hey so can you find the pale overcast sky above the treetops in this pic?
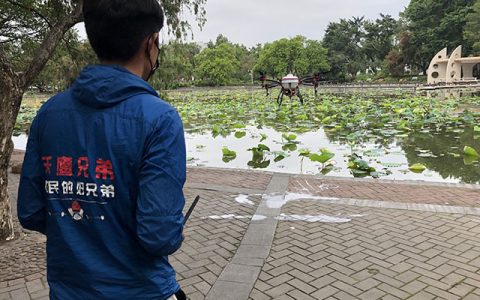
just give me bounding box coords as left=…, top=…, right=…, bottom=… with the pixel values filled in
left=77, top=0, right=410, bottom=47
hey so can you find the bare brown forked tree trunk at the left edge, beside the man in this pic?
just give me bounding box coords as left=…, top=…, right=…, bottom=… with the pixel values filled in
left=0, top=0, right=83, bottom=241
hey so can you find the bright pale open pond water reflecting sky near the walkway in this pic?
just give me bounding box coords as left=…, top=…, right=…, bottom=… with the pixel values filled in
left=186, top=126, right=458, bottom=182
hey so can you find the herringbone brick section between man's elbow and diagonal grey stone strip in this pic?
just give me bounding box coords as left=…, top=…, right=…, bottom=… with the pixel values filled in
left=170, top=189, right=260, bottom=299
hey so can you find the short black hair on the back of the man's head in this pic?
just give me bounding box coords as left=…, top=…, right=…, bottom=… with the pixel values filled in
left=83, top=0, right=164, bottom=62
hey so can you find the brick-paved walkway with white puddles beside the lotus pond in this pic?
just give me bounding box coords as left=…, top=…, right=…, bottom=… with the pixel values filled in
left=0, top=151, right=480, bottom=300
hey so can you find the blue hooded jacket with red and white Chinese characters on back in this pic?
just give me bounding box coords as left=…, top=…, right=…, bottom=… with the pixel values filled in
left=18, top=65, right=186, bottom=300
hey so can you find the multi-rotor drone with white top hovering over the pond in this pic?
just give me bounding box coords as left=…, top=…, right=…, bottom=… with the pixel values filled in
left=259, top=73, right=323, bottom=106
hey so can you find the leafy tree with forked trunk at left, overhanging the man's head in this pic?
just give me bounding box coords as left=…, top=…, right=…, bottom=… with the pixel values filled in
left=0, top=0, right=206, bottom=240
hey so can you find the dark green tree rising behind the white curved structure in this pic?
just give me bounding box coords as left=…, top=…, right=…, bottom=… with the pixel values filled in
left=403, top=0, right=478, bottom=74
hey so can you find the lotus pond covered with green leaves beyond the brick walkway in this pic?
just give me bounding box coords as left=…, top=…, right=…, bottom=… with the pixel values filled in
left=14, top=90, right=480, bottom=183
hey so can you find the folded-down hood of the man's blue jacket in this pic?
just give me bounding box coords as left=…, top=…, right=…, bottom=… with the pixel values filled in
left=72, top=65, right=158, bottom=108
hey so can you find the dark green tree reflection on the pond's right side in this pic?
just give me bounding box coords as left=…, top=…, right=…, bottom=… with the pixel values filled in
left=326, top=125, right=480, bottom=183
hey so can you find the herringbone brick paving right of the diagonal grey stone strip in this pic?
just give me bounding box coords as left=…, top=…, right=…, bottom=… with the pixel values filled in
left=250, top=201, right=480, bottom=300
